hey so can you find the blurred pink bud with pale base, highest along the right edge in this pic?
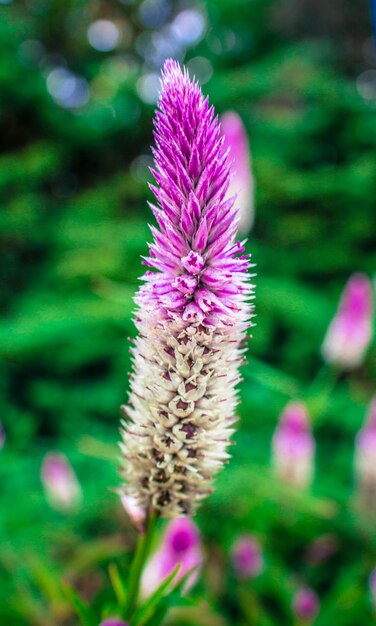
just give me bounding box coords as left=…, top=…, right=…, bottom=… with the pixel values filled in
left=321, top=274, right=373, bottom=370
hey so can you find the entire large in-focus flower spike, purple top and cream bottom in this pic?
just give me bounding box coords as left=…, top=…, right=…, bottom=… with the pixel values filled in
left=121, top=60, right=252, bottom=517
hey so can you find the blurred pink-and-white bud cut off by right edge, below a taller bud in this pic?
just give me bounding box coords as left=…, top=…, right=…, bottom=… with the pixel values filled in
left=355, top=396, right=376, bottom=513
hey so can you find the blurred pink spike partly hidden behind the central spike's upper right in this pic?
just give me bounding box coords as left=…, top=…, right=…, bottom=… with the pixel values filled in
left=220, top=111, right=255, bottom=235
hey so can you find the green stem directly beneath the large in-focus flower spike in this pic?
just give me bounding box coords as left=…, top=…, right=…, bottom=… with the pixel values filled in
left=124, top=512, right=157, bottom=621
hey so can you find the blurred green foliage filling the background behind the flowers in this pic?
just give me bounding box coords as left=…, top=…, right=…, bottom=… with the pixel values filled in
left=0, top=0, right=376, bottom=626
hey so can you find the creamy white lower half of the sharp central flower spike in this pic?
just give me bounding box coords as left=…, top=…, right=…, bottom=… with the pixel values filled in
left=121, top=313, right=245, bottom=517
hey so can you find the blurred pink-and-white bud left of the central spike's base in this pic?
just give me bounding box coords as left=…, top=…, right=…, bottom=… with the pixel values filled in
left=41, top=452, right=82, bottom=511
